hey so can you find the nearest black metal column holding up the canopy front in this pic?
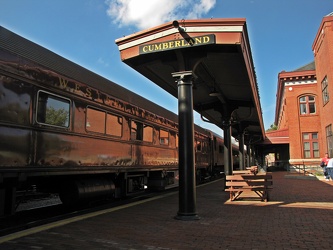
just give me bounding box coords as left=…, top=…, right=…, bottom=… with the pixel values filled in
left=172, top=71, right=199, bottom=220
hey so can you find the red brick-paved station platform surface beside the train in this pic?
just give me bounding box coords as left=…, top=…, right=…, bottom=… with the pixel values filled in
left=0, top=172, right=333, bottom=250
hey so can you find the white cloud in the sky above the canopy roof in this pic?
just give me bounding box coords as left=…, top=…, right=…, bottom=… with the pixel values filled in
left=106, top=0, right=216, bottom=29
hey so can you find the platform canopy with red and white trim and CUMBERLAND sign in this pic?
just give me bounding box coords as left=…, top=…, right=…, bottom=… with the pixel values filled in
left=116, top=18, right=265, bottom=143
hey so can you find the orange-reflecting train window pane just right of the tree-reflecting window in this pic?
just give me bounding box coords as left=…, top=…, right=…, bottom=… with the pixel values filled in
left=86, top=108, right=105, bottom=134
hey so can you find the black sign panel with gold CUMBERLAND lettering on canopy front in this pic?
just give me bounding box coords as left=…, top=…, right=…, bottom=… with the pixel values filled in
left=139, top=34, right=215, bottom=54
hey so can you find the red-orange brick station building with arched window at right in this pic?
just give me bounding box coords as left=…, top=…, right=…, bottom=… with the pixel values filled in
left=275, top=13, right=333, bottom=165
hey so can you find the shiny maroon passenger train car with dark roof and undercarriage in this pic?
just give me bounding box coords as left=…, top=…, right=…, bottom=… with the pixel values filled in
left=0, top=27, right=239, bottom=216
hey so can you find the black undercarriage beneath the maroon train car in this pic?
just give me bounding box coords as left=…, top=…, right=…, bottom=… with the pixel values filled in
left=0, top=165, right=223, bottom=217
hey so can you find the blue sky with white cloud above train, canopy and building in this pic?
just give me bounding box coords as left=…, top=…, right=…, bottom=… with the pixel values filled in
left=0, top=0, right=333, bottom=133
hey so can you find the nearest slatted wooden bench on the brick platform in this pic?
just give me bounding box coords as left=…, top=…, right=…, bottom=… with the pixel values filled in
left=225, top=173, right=273, bottom=202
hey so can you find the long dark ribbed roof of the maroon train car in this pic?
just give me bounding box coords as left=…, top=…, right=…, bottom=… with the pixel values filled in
left=0, top=26, right=182, bottom=123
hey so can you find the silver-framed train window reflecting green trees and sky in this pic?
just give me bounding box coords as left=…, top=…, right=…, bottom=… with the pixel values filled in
left=37, top=91, right=70, bottom=128
